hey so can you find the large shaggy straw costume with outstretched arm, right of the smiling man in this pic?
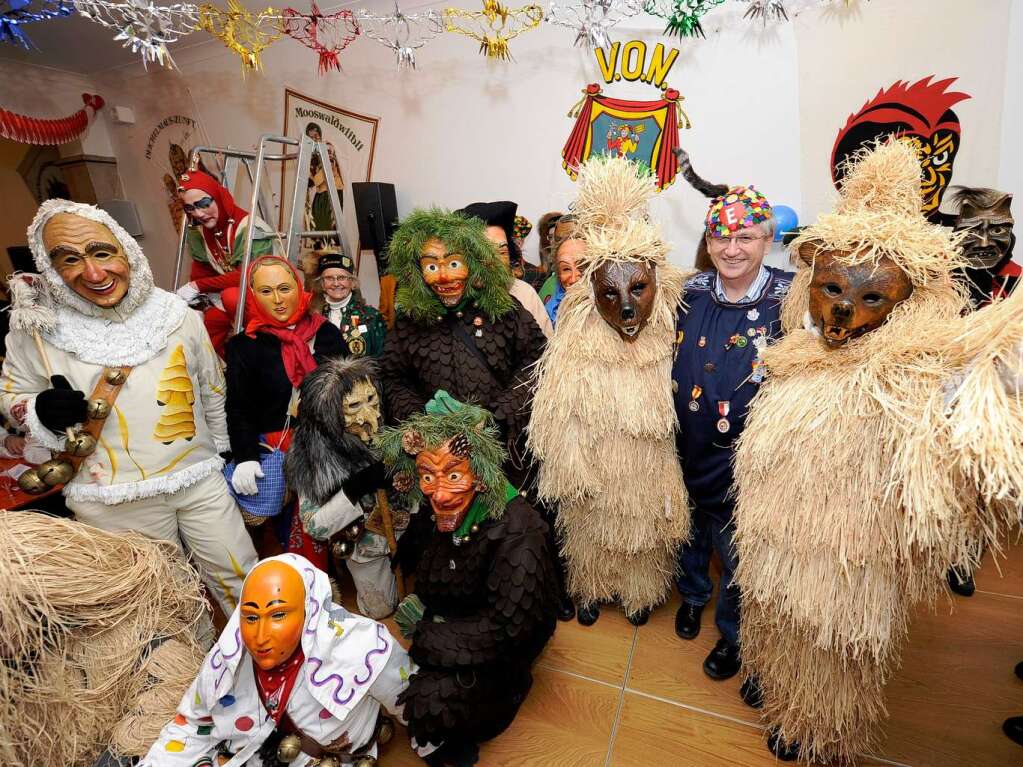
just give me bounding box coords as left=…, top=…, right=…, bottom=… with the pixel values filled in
left=735, top=142, right=1023, bottom=763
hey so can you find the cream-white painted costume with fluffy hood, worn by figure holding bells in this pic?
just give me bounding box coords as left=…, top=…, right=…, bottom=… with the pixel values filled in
left=0, top=199, right=256, bottom=613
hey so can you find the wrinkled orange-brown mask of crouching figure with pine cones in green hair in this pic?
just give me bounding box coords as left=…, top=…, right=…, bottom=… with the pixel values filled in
left=415, top=437, right=477, bottom=533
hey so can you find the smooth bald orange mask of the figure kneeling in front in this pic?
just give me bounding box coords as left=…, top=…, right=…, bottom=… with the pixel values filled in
left=240, top=560, right=306, bottom=671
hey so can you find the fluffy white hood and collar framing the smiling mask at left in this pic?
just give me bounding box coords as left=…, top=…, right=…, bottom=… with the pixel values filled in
left=23, top=199, right=188, bottom=366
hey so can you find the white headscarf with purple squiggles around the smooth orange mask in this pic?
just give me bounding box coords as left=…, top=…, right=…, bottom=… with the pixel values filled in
left=198, top=554, right=394, bottom=719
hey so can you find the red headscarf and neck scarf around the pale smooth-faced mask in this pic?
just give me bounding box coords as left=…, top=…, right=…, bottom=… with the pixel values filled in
left=246, top=256, right=326, bottom=389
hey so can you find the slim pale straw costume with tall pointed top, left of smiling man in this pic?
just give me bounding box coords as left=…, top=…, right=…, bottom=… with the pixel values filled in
left=529, top=159, right=688, bottom=622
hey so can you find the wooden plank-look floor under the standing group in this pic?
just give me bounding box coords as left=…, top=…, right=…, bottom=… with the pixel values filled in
left=381, top=546, right=1023, bottom=767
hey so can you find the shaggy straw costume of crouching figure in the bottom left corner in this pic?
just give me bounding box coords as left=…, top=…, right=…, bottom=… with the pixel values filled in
left=0, top=511, right=209, bottom=767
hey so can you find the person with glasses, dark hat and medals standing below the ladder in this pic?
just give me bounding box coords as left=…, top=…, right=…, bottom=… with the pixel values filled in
left=312, top=251, right=387, bottom=357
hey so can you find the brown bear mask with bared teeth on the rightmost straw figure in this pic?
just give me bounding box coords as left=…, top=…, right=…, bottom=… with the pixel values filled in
left=809, top=251, right=913, bottom=349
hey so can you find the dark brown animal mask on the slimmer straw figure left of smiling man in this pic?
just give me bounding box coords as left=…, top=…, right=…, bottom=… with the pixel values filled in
left=591, top=261, right=657, bottom=342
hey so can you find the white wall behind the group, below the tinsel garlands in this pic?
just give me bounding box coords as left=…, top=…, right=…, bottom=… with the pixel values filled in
left=0, top=0, right=1023, bottom=284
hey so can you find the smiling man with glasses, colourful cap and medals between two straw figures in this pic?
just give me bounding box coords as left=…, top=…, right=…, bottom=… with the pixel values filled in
left=672, top=186, right=792, bottom=702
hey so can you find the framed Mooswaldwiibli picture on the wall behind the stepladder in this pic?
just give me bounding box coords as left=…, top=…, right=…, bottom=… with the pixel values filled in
left=279, top=88, right=380, bottom=267
